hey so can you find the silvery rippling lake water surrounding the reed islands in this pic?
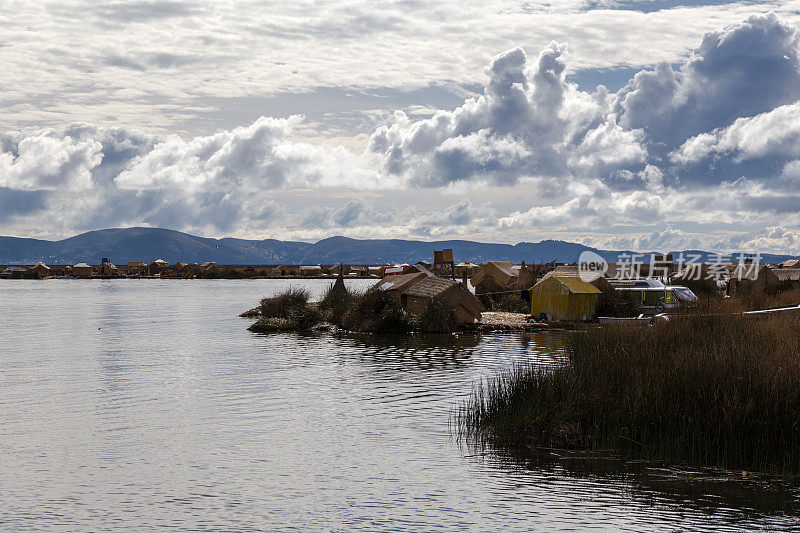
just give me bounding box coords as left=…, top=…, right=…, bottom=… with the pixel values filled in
left=0, top=280, right=800, bottom=531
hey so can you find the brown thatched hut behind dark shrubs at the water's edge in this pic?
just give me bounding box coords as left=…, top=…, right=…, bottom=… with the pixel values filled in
left=401, top=277, right=483, bottom=324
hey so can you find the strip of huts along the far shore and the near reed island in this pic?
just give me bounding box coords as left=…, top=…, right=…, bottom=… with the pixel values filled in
left=6, top=249, right=800, bottom=329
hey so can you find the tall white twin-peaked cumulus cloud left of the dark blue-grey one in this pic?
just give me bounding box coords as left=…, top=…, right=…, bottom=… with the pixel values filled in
left=369, top=43, right=646, bottom=186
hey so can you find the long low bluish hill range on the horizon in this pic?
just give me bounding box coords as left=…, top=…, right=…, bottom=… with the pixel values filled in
left=0, top=228, right=792, bottom=264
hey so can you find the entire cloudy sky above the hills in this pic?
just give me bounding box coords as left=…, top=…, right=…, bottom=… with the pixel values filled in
left=0, top=0, right=800, bottom=254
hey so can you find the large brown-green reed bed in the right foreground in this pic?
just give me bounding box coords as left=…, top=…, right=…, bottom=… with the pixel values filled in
left=457, top=314, right=800, bottom=479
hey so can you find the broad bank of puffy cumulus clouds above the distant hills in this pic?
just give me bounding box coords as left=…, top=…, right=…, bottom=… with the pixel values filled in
left=0, top=10, right=800, bottom=254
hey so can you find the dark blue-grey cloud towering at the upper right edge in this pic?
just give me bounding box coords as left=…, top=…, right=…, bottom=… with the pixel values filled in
left=612, top=13, right=800, bottom=148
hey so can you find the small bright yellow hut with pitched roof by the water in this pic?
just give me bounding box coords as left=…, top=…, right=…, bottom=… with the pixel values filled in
left=531, top=276, right=601, bottom=320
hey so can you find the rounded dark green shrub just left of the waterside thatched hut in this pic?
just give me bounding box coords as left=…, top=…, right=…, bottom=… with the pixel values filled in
left=342, top=290, right=412, bottom=333
